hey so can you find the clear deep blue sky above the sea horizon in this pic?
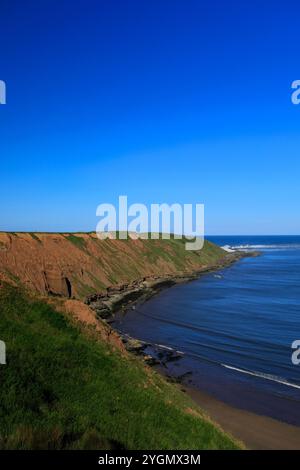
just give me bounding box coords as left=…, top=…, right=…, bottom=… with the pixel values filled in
left=0, top=0, right=300, bottom=234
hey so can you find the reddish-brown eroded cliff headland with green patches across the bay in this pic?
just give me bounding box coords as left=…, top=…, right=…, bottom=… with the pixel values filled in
left=0, top=232, right=224, bottom=299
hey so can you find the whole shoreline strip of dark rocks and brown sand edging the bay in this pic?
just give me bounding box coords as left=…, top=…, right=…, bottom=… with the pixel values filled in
left=89, top=252, right=300, bottom=450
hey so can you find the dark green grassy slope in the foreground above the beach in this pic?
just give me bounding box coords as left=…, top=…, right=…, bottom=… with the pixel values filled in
left=0, top=285, right=238, bottom=449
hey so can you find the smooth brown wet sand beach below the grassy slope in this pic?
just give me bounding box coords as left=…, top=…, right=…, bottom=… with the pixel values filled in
left=184, top=386, right=300, bottom=450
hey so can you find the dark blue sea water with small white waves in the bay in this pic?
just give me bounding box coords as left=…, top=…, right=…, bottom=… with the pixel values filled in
left=115, top=236, right=300, bottom=425
